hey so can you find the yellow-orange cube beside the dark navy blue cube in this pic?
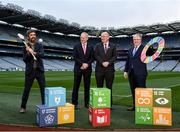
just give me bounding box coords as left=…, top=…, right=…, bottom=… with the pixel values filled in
left=58, top=103, right=74, bottom=124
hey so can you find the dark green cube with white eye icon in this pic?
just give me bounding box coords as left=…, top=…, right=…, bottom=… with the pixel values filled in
left=153, top=88, right=171, bottom=107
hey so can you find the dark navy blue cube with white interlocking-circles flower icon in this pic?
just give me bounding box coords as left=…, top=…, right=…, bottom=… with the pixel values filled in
left=36, top=105, right=58, bottom=127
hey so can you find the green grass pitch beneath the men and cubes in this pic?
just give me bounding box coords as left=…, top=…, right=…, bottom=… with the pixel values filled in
left=0, top=71, right=180, bottom=130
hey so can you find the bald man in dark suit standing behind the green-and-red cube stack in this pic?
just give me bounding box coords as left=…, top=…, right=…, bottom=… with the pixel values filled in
left=94, top=32, right=116, bottom=106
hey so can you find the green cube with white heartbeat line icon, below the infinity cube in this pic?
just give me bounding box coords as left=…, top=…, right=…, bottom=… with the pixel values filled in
left=135, top=107, right=153, bottom=125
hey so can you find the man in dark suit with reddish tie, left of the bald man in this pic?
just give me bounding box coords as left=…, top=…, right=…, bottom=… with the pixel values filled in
left=72, top=32, right=93, bottom=109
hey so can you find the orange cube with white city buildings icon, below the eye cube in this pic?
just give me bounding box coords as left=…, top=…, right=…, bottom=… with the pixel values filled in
left=153, top=107, right=172, bottom=126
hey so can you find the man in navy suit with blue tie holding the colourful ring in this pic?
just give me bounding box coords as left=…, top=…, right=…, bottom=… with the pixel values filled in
left=124, top=34, right=147, bottom=111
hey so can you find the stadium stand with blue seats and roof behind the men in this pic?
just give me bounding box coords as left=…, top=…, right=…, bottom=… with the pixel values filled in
left=0, top=3, right=180, bottom=71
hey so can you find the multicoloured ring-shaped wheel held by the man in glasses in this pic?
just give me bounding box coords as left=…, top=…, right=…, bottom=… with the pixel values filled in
left=141, top=37, right=165, bottom=63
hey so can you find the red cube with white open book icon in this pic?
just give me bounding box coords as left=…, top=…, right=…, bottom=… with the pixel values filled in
left=89, top=107, right=110, bottom=127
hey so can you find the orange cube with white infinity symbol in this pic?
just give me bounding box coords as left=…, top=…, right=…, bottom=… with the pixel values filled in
left=135, top=88, right=153, bottom=107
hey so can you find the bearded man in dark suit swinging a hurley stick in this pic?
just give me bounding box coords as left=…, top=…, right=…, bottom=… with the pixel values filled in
left=20, top=30, right=45, bottom=113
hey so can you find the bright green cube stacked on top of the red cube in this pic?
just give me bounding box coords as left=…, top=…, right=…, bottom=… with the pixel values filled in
left=89, top=88, right=111, bottom=108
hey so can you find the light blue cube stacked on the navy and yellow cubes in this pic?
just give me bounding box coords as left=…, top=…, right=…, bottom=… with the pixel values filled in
left=45, top=87, right=66, bottom=107
